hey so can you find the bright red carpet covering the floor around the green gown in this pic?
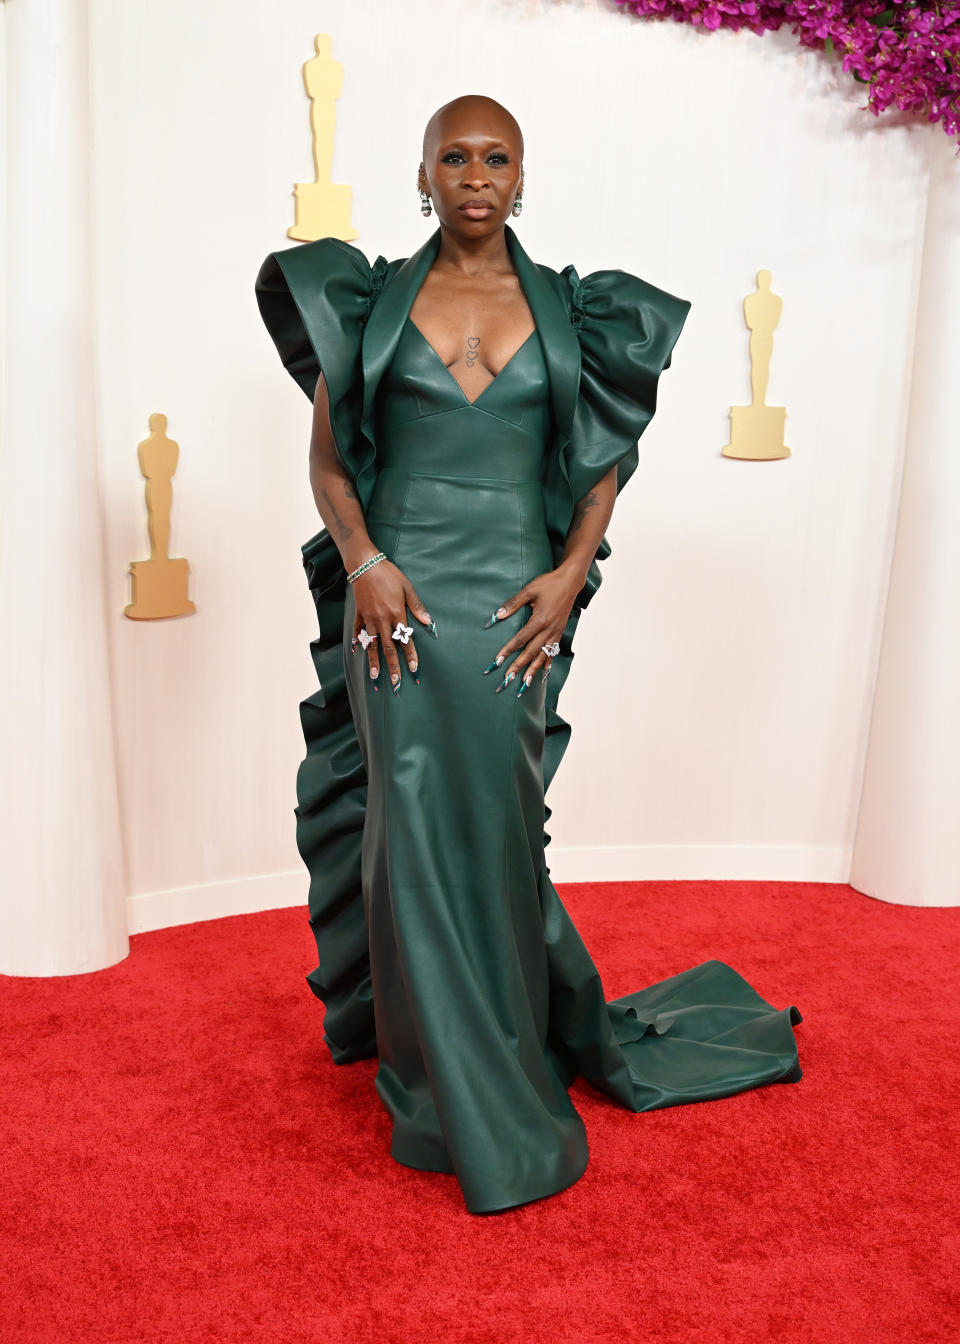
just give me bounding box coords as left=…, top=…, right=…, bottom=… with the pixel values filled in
left=0, top=882, right=960, bottom=1344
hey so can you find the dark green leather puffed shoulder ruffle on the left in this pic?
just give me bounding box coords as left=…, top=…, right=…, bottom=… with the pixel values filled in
left=255, top=238, right=399, bottom=483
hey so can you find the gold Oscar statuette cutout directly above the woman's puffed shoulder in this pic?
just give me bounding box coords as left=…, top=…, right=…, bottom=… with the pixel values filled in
left=286, top=32, right=356, bottom=243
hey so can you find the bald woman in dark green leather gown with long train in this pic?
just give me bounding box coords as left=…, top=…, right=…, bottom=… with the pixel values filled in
left=257, top=95, right=801, bottom=1214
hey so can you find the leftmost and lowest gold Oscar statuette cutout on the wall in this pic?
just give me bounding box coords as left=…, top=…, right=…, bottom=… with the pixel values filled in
left=124, top=411, right=196, bottom=621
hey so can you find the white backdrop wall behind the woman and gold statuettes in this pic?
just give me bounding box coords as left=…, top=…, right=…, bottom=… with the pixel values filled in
left=7, top=0, right=960, bottom=973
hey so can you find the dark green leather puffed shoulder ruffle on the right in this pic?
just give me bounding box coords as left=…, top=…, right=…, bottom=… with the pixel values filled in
left=561, top=266, right=691, bottom=500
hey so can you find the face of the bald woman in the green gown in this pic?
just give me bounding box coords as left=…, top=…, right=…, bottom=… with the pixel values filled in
left=419, top=110, right=523, bottom=238
